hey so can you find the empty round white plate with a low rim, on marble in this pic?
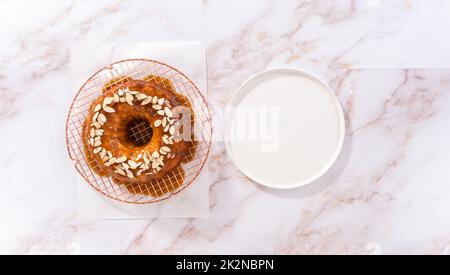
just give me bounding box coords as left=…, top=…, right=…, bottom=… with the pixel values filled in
left=224, top=69, right=345, bottom=189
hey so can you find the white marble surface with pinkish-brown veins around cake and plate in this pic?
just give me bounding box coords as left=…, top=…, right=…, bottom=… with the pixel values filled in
left=0, top=0, right=450, bottom=254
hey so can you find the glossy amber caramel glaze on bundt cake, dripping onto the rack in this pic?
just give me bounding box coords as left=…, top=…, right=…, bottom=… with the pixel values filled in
left=82, top=75, right=197, bottom=197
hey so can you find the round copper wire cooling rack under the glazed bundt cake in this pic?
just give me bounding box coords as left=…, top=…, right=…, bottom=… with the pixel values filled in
left=66, top=59, right=212, bottom=204
